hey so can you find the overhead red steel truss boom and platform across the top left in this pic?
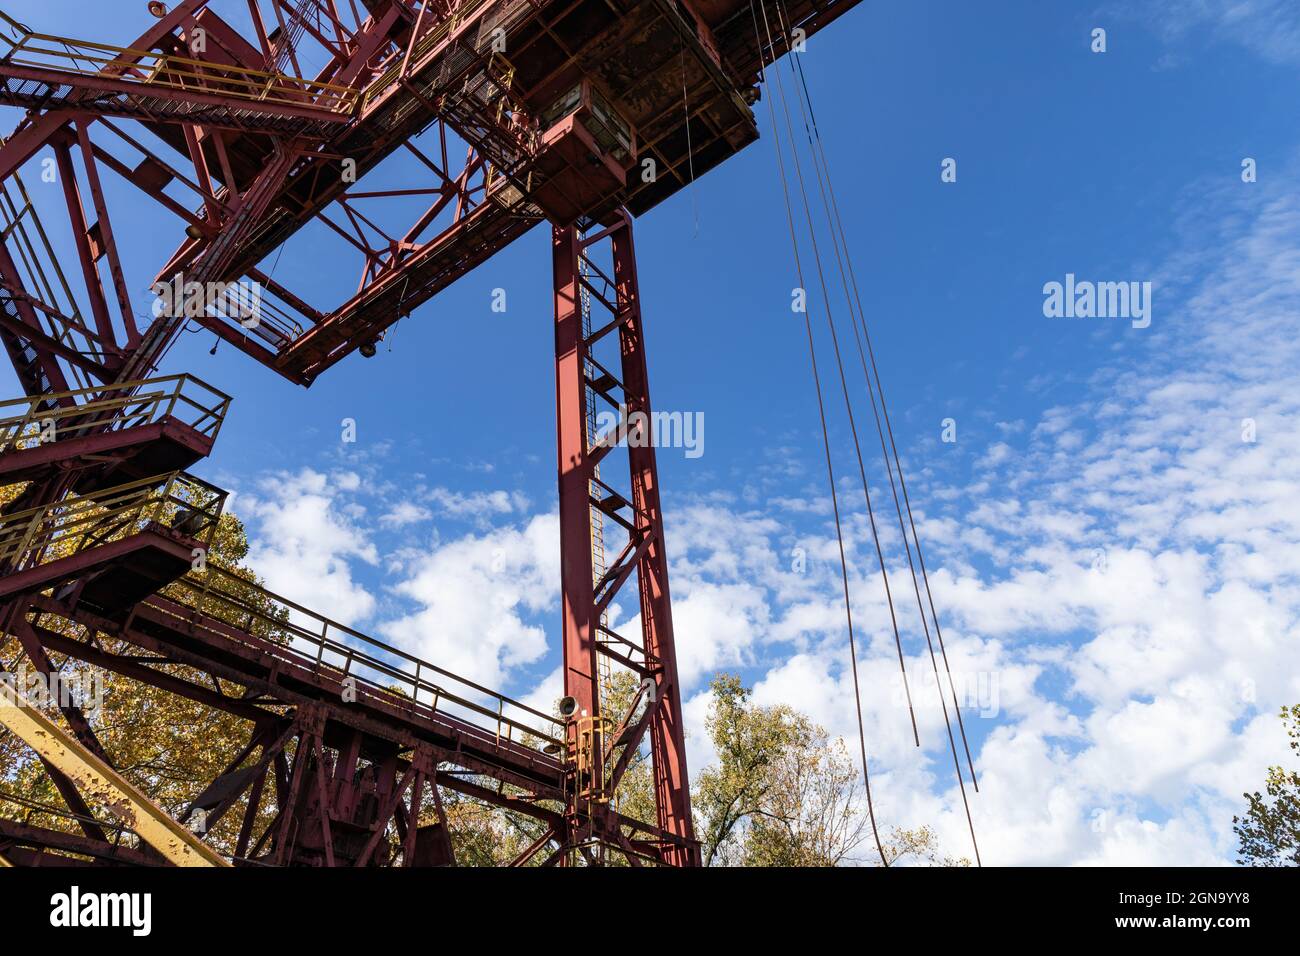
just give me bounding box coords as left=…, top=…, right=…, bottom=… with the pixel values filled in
left=0, top=0, right=854, bottom=392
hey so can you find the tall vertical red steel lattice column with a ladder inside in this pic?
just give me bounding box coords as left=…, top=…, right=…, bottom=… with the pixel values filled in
left=553, top=212, right=699, bottom=866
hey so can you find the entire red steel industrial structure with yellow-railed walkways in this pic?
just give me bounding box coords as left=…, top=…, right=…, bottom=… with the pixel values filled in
left=0, top=0, right=873, bottom=866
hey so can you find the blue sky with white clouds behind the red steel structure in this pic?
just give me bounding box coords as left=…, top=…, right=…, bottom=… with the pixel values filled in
left=0, top=0, right=1300, bottom=864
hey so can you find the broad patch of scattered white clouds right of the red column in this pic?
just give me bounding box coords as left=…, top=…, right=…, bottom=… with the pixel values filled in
left=626, top=174, right=1300, bottom=865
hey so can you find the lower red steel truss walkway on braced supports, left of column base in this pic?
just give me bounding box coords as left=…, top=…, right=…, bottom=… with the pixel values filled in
left=0, top=582, right=563, bottom=866
